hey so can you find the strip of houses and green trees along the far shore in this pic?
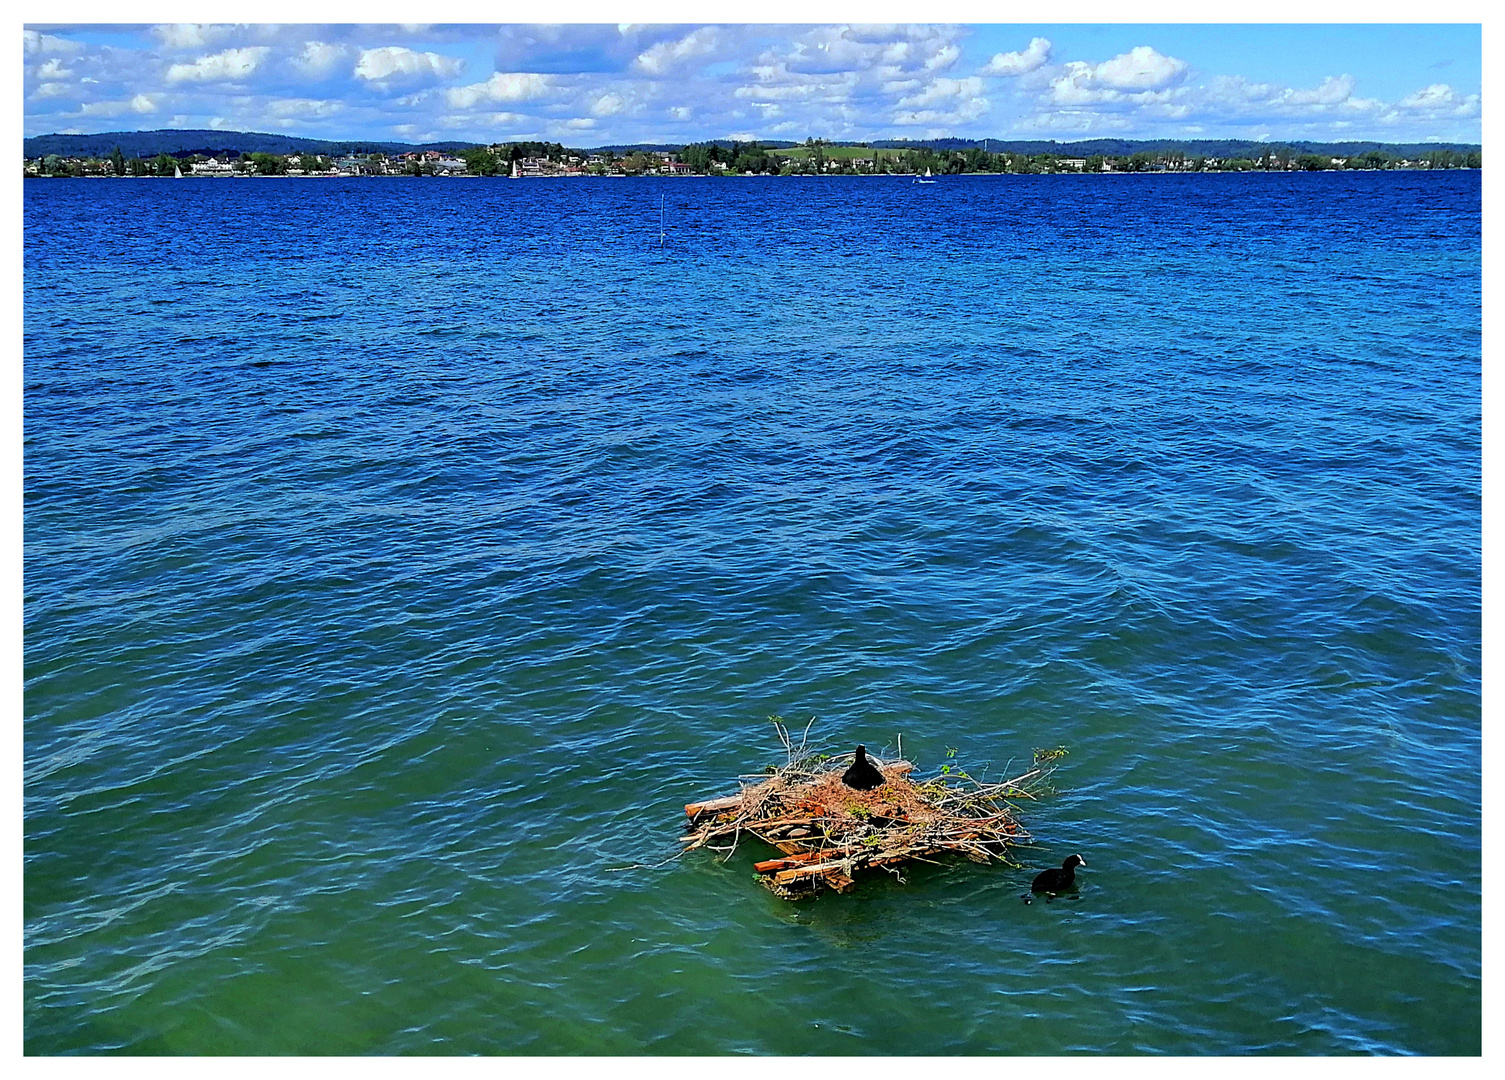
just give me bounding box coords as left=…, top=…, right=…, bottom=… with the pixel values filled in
left=24, top=138, right=1481, bottom=179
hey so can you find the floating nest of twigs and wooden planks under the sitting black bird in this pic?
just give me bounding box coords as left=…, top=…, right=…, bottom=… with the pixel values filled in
left=680, top=719, right=1066, bottom=899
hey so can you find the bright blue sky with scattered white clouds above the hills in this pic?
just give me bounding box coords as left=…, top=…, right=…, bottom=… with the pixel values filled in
left=24, top=23, right=1482, bottom=146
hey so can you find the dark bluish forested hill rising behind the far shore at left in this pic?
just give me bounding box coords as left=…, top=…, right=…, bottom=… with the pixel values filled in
left=23, top=128, right=476, bottom=158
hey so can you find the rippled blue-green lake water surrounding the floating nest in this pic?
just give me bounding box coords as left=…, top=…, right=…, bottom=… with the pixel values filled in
left=24, top=173, right=1481, bottom=1054
